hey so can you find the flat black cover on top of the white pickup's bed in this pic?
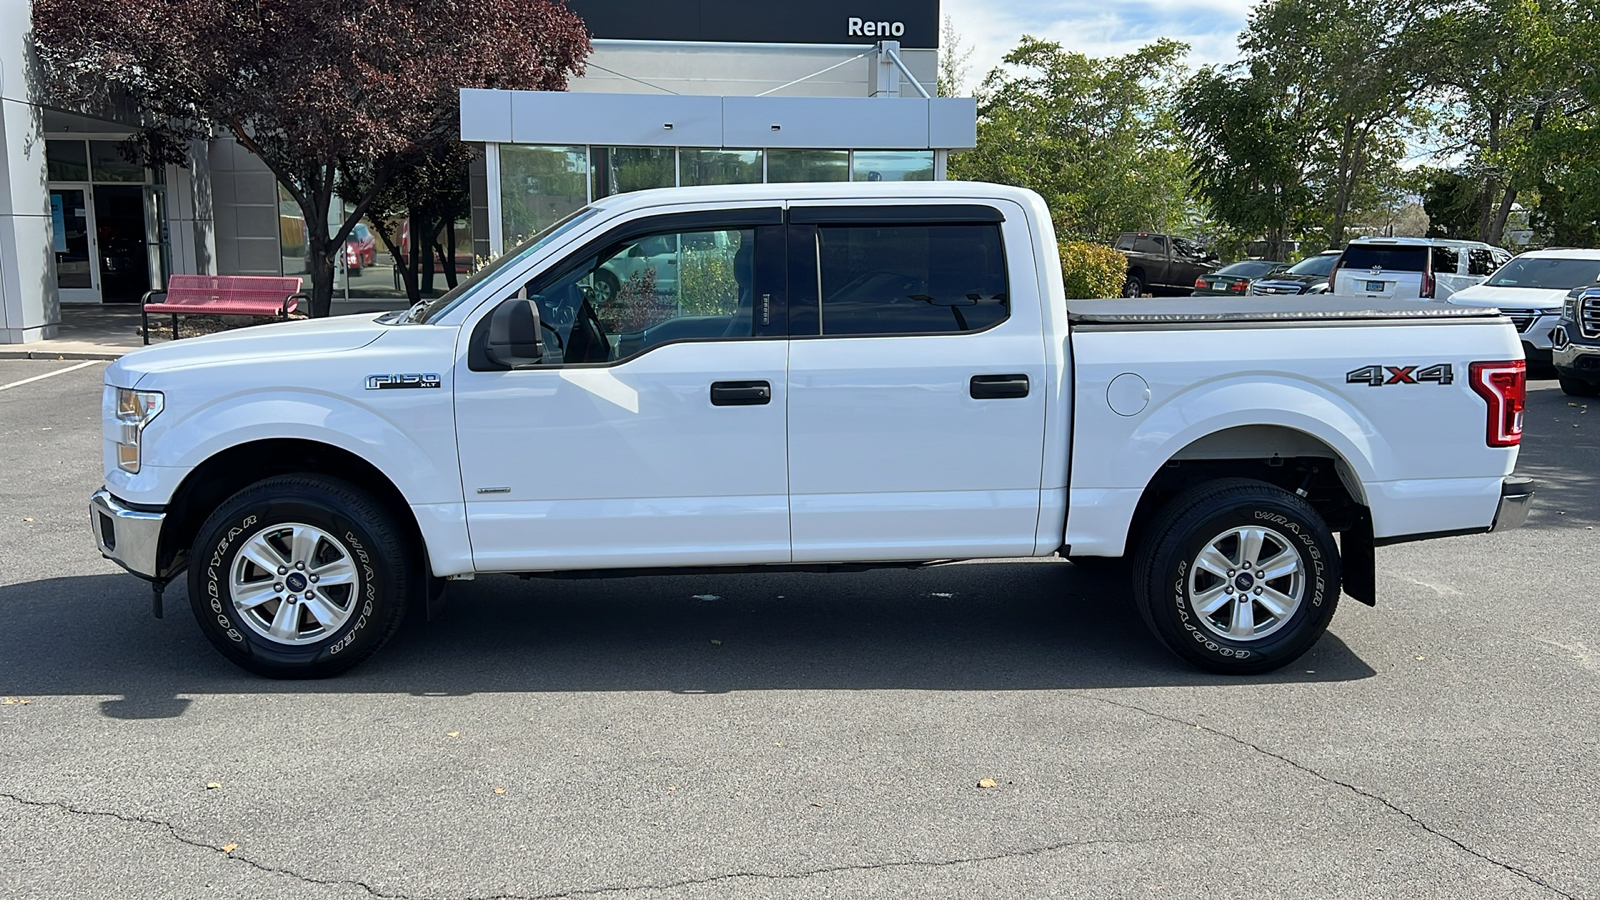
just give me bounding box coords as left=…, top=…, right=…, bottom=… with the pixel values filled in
left=1067, top=296, right=1499, bottom=330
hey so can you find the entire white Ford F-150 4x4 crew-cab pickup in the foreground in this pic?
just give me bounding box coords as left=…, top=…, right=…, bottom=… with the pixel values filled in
left=90, top=183, right=1533, bottom=677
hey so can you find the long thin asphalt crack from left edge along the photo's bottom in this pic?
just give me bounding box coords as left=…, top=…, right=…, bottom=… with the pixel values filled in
left=0, top=791, right=1155, bottom=900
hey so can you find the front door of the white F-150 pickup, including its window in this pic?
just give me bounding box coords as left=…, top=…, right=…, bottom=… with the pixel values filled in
left=456, top=208, right=789, bottom=572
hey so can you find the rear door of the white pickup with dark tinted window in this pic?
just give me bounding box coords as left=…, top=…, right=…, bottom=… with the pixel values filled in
left=789, top=202, right=1045, bottom=562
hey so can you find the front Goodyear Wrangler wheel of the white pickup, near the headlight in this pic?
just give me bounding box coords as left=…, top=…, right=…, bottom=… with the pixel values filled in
left=189, top=476, right=416, bottom=677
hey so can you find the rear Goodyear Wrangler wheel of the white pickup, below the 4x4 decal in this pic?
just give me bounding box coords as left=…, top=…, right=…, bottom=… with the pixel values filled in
left=1134, top=479, right=1339, bottom=674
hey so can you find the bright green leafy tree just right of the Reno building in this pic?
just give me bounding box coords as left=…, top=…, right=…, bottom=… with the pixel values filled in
left=950, top=37, right=1190, bottom=240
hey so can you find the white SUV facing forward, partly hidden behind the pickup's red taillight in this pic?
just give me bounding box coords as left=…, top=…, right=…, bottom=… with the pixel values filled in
left=1450, top=250, right=1600, bottom=365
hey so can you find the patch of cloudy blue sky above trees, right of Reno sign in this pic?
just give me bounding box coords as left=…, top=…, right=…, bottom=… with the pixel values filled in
left=939, top=0, right=1254, bottom=91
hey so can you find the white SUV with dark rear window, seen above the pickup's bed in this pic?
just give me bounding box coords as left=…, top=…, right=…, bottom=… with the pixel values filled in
left=1328, top=237, right=1510, bottom=299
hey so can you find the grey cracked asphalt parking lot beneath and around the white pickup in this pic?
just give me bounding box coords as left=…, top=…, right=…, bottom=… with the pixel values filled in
left=0, top=353, right=1600, bottom=900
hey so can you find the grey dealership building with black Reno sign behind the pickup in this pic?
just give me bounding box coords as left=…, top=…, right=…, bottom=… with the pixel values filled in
left=0, top=0, right=976, bottom=344
